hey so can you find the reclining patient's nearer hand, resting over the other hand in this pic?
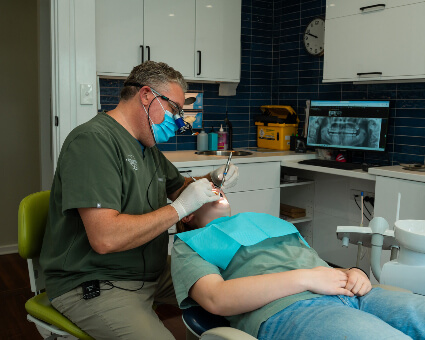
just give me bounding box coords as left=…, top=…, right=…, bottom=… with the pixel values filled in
left=307, top=267, right=354, bottom=296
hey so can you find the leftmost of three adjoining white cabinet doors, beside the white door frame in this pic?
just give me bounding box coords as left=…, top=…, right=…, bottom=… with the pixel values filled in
left=95, top=0, right=143, bottom=75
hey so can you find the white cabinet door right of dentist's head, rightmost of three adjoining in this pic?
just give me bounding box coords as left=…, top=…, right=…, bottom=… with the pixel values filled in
left=194, top=0, right=241, bottom=81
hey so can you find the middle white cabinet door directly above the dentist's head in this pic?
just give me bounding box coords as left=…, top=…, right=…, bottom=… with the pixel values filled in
left=143, top=0, right=195, bottom=79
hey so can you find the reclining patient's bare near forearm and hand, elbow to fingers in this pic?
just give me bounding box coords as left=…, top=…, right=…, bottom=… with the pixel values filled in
left=189, top=267, right=353, bottom=316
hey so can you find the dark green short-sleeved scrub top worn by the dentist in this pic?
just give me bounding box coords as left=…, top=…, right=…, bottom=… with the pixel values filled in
left=40, top=113, right=184, bottom=299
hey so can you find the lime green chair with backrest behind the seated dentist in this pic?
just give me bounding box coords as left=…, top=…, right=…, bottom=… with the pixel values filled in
left=18, top=191, right=93, bottom=340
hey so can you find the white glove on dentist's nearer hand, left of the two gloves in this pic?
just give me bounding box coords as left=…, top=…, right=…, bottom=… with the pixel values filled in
left=171, top=178, right=220, bottom=220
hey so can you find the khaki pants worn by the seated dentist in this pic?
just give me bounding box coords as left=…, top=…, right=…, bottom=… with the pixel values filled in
left=52, top=257, right=177, bottom=340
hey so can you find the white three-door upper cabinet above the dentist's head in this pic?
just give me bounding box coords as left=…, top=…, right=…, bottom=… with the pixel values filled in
left=96, top=0, right=242, bottom=82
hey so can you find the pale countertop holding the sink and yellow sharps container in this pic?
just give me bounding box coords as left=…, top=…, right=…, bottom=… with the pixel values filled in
left=164, top=149, right=316, bottom=168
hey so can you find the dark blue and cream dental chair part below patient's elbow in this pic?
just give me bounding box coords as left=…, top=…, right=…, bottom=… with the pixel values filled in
left=182, top=306, right=255, bottom=340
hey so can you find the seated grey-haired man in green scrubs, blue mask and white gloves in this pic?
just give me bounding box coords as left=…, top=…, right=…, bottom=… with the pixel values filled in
left=40, top=61, right=238, bottom=339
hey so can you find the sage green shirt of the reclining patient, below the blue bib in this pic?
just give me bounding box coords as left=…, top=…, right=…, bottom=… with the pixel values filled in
left=171, top=234, right=329, bottom=337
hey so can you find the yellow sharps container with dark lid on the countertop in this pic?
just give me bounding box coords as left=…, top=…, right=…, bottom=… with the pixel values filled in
left=255, top=105, right=299, bottom=150
